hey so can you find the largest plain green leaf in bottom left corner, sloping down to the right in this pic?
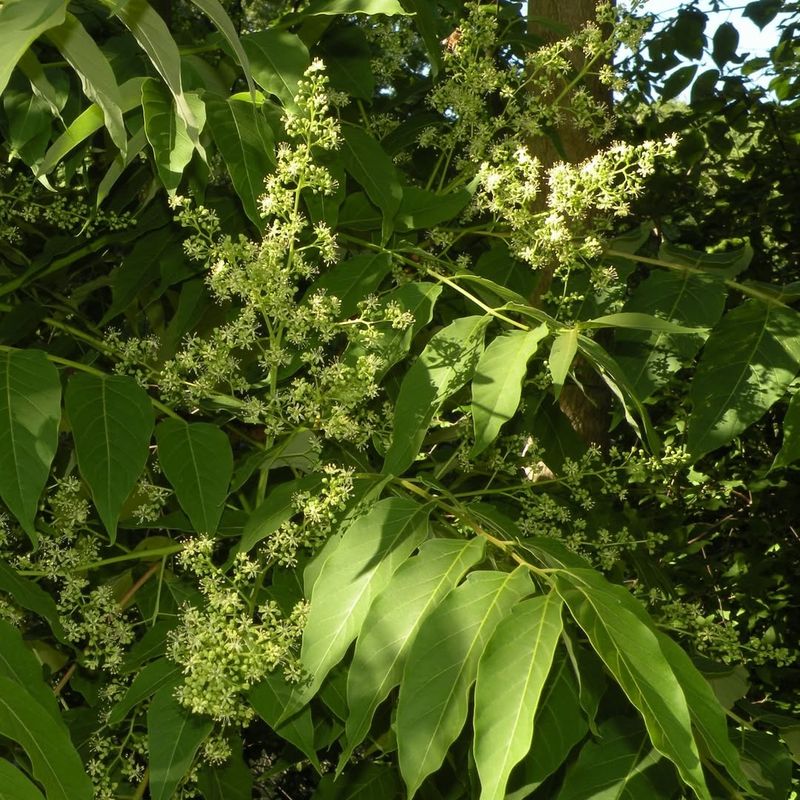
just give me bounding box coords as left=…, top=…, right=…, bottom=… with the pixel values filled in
left=0, top=676, right=94, bottom=800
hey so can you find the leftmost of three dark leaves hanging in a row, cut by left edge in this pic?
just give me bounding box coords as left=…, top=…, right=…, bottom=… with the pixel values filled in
left=0, top=350, right=61, bottom=545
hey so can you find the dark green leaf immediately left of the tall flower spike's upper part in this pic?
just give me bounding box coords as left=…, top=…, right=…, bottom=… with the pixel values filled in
left=205, top=94, right=275, bottom=228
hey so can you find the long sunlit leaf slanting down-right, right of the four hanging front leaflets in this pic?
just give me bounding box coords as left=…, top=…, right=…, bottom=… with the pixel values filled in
left=555, top=569, right=711, bottom=800
